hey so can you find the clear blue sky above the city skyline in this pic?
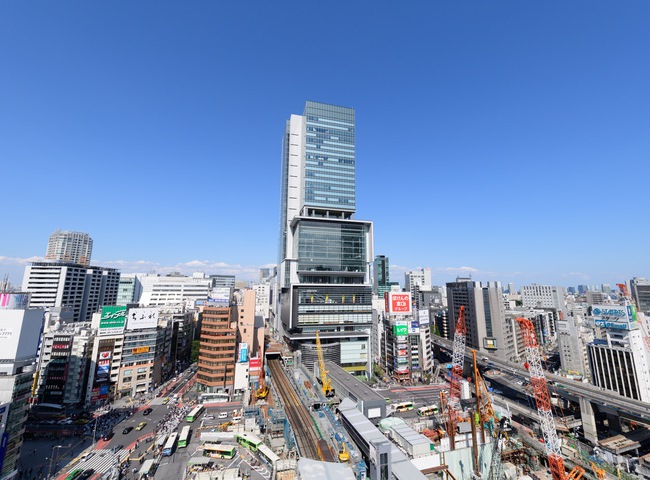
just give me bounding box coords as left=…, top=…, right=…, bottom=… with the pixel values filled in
left=0, top=0, right=650, bottom=285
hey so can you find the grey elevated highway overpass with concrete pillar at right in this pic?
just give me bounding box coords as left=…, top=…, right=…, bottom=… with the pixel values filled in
left=431, top=335, right=650, bottom=444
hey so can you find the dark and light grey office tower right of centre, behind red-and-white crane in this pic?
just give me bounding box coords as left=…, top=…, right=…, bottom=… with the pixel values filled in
left=447, top=278, right=506, bottom=359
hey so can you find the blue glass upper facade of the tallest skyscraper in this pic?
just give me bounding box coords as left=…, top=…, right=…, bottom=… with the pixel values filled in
left=304, top=102, right=356, bottom=210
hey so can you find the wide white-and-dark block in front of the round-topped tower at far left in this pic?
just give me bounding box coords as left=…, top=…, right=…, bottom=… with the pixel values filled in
left=23, top=262, right=120, bottom=322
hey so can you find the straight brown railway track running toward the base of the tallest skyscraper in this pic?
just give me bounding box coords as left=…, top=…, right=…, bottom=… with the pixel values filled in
left=269, top=360, right=322, bottom=460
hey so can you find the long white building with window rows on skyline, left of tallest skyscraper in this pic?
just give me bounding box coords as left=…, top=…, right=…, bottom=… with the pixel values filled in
left=140, top=272, right=213, bottom=307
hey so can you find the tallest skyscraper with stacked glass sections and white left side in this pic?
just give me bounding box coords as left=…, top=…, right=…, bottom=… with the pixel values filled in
left=275, top=102, right=373, bottom=375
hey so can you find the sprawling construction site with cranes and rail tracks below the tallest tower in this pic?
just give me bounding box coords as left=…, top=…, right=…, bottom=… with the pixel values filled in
left=194, top=307, right=642, bottom=480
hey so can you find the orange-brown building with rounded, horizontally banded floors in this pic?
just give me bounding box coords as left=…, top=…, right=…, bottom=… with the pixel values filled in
left=196, top=306, right=237, bottom=397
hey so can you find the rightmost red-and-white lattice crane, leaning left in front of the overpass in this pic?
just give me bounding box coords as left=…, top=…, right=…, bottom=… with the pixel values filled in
left=517, top=317, right=585, bottom=480
